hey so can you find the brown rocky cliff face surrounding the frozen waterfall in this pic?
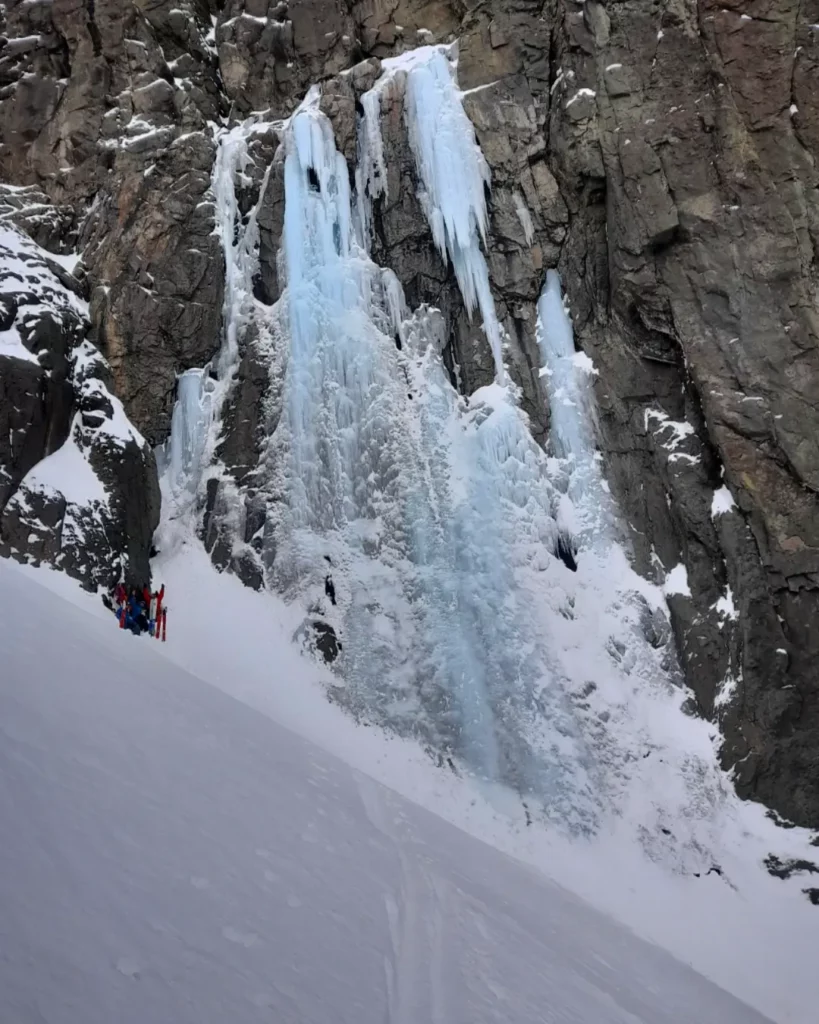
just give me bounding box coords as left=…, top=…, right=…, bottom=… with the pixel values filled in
left=0, top=0, right=819, bottom=826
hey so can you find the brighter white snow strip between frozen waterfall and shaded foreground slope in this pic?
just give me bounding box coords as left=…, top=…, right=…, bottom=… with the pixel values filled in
left=12, top=542, right=819, bottom=1024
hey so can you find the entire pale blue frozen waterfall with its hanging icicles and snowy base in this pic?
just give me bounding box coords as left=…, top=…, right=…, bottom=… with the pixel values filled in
left=156, top=48, right=737, bottom=847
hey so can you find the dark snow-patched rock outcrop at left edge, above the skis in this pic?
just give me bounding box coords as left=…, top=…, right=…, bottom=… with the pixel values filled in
left=0, top=220, right=159, bottom=586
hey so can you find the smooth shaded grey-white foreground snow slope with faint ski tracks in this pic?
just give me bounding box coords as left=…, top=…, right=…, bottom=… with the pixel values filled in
left=0, top=563, right=765, bottom=1024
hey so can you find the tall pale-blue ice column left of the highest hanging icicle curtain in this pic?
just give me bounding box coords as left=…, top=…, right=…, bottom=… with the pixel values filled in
left=283, top=90, right=388, bottom=528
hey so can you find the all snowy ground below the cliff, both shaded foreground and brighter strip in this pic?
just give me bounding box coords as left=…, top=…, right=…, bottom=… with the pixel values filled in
left=6, top=548, right=819, bottom=1024
